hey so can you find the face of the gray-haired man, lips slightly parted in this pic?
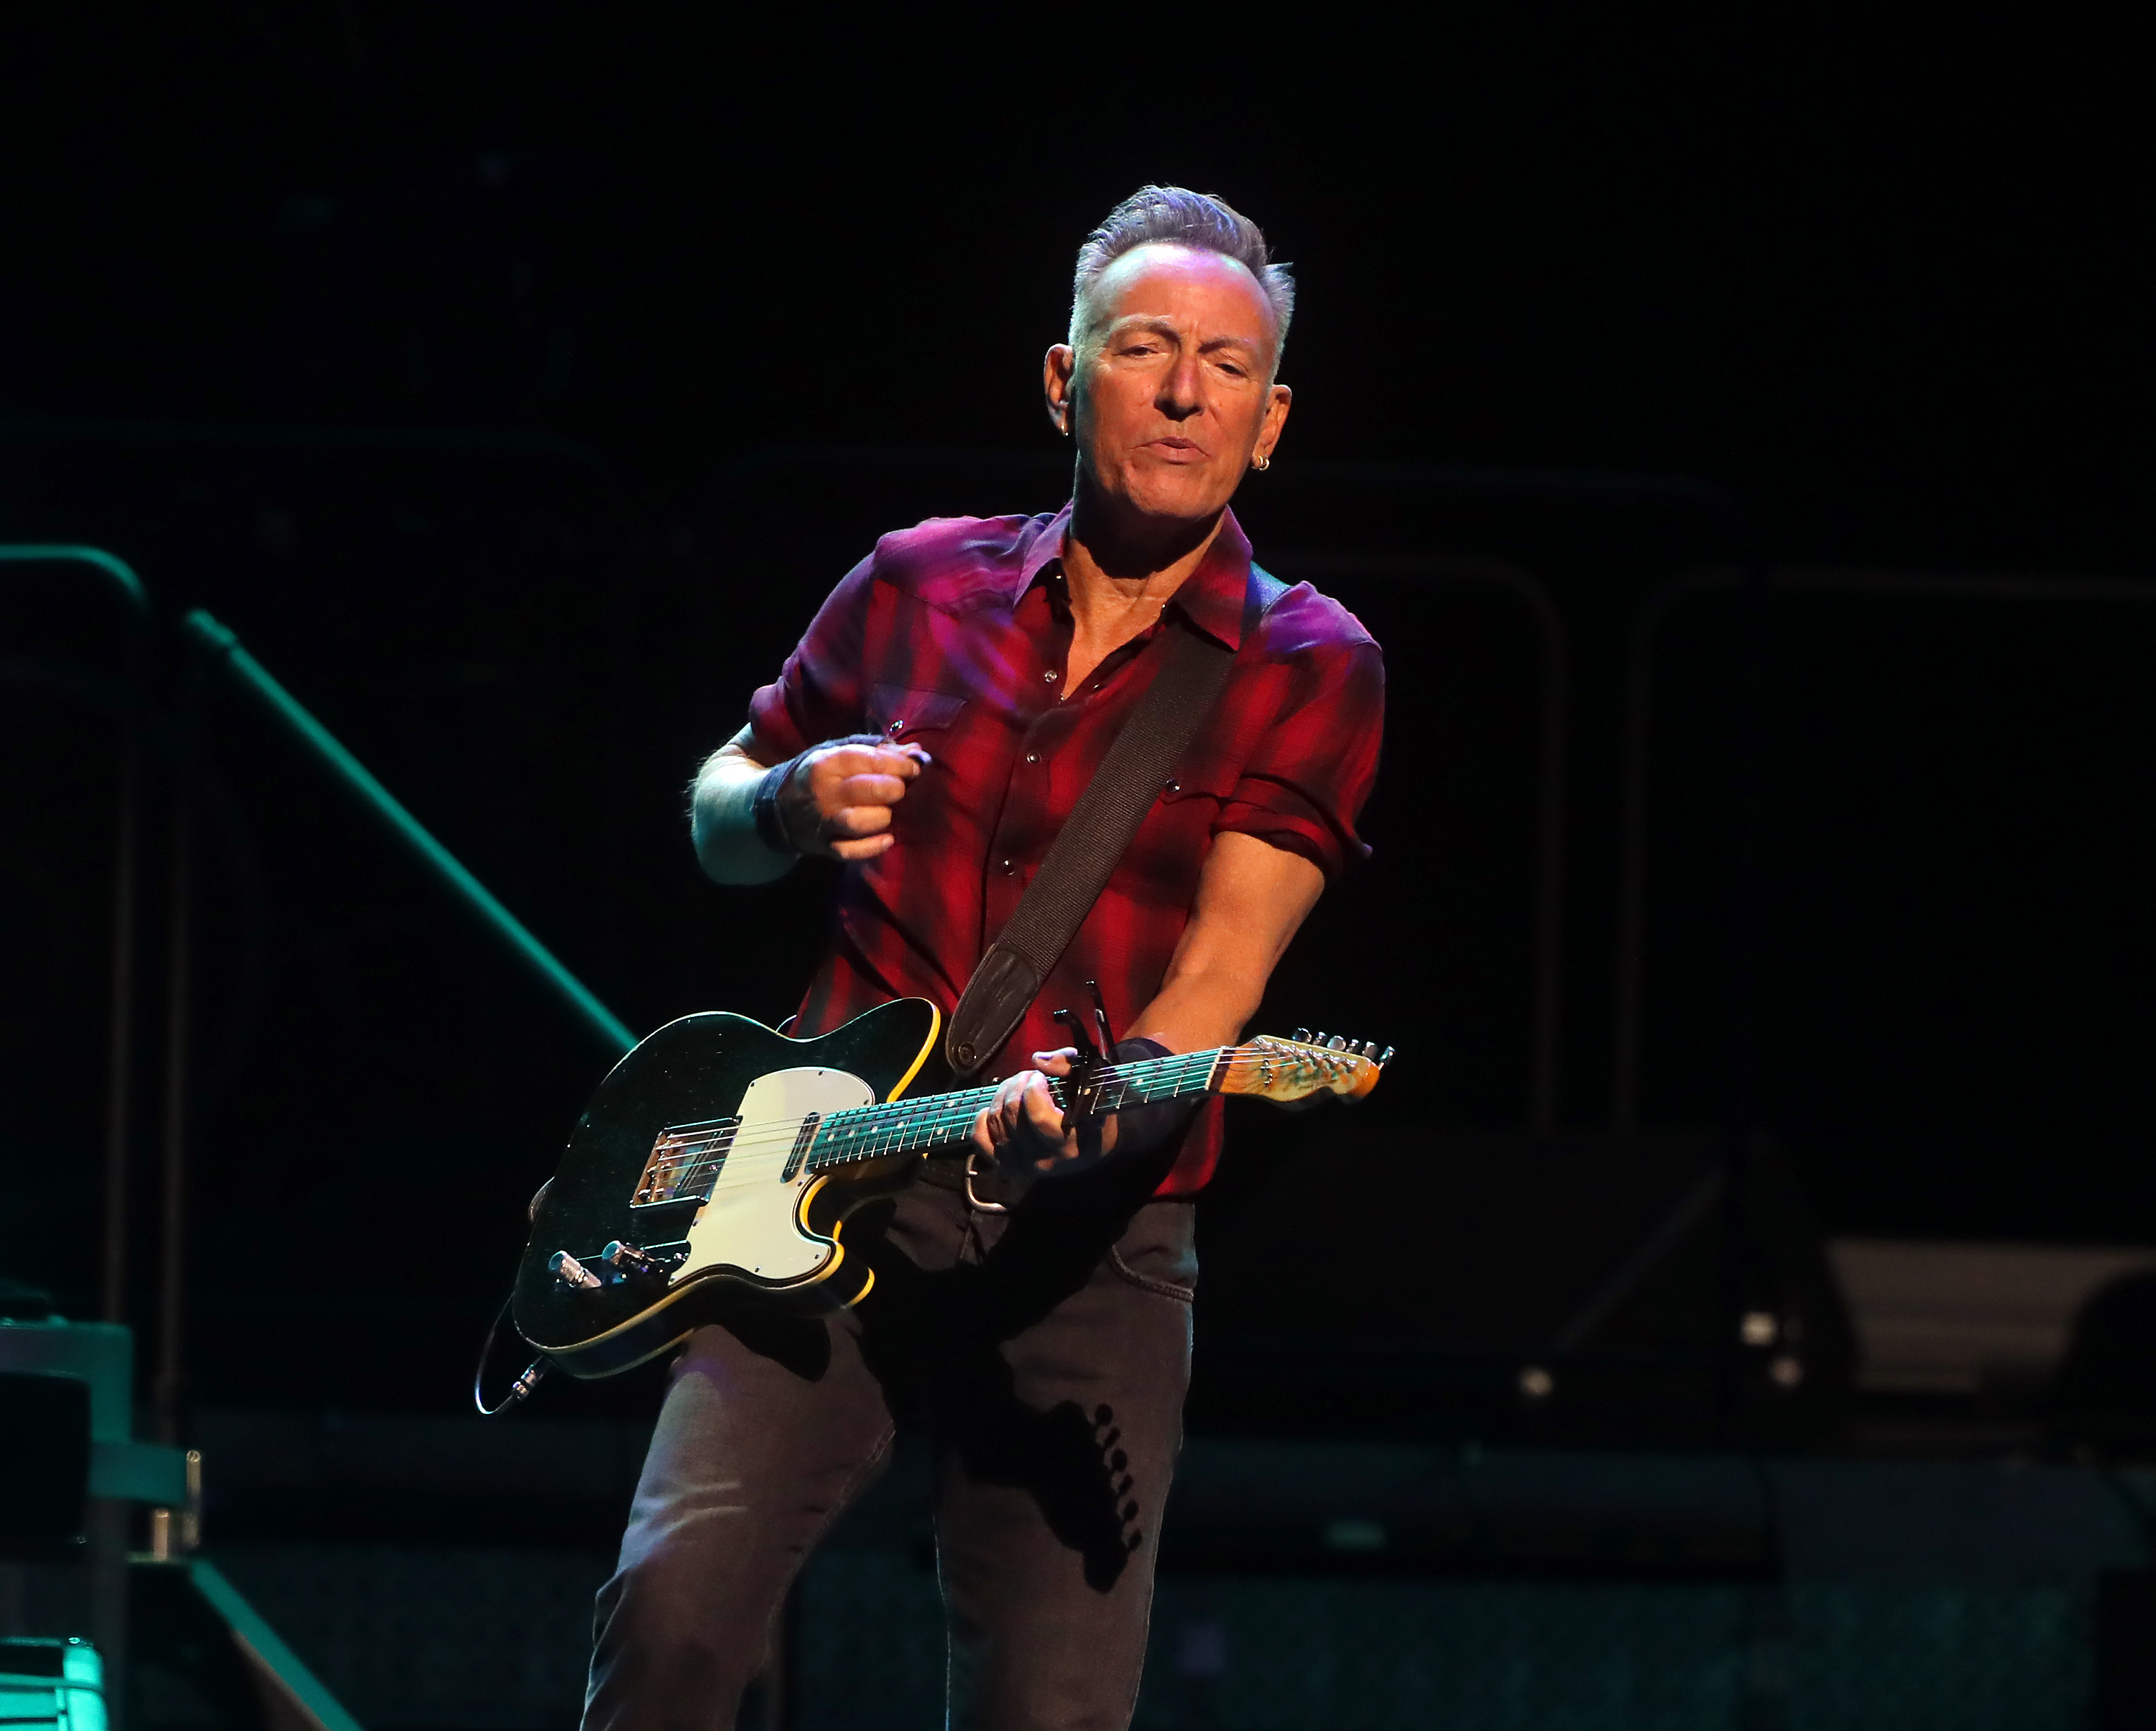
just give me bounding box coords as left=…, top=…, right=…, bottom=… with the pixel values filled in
left=1050, top=244, right=1287, bottom=522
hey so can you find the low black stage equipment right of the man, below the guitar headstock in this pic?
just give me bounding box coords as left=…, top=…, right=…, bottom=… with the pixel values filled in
left=1192, top=1121, right=1854, bottom=1446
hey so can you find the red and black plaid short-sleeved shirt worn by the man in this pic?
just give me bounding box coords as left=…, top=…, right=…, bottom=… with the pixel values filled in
left=748, top=507, right=1384, bottom=1194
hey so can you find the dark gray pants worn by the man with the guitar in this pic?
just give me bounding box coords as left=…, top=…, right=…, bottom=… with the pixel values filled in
left=584, top=1160, right=1197, bottom=1731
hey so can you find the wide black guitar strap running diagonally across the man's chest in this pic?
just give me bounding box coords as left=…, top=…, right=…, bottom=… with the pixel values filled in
left=944, top=565, right=1287, bottom=1080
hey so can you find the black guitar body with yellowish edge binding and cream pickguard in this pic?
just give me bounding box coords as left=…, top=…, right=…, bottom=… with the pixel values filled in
left=513, top=998, right=949, bottom=1377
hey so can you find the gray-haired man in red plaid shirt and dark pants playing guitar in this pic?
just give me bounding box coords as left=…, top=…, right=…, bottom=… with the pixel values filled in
left=586, top=188, right=1384, bottom=1731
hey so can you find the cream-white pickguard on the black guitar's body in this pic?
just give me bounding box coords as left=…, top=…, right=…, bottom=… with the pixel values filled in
left=673, top=1069, right=875, bottom=1280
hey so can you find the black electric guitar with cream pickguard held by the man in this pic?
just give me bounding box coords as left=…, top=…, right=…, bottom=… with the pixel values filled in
left=513, top=998, right=1393, bottom=1377
